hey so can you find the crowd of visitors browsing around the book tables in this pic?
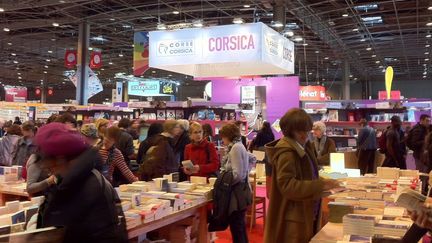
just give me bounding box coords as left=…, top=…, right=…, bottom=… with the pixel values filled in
left=0, top=109, right=432, bottom=243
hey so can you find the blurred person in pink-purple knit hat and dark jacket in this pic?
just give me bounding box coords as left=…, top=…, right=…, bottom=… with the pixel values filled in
left=35, top=122, right=127, bottom=243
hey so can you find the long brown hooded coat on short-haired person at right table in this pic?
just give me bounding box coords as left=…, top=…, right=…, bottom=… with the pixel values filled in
left=264, top=137, right=324, bottom=243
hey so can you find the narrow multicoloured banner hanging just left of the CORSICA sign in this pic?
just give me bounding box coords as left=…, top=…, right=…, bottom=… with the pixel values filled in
left=134, top=32, right=149, bottom=76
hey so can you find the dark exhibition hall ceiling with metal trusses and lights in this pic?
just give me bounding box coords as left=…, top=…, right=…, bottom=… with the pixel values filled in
left=0, top=0, right=432, bottom=88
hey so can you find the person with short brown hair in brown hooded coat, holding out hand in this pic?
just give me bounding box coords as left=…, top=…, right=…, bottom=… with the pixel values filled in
left=264, top=108, right=339, bottom=243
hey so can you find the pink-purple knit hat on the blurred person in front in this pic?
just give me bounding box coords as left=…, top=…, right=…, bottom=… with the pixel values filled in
left=35, top=122, right=88, bottom=159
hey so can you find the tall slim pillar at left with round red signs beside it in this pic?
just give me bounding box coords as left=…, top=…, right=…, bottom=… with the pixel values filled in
left=76, top=21, right=90, bottom=105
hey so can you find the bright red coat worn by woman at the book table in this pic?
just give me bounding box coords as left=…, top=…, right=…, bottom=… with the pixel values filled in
left=184, top=139, right=220, bottom=177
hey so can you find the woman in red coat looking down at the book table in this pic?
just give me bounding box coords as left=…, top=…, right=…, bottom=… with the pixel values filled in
left=183, top=122, right=220, bottom=177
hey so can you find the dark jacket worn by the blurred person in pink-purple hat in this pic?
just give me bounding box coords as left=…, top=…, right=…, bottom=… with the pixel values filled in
left=38, top=149, right=127, bottom=243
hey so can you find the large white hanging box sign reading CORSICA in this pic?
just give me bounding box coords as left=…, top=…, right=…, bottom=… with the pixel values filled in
left=149, top=23, right=294, bottom=77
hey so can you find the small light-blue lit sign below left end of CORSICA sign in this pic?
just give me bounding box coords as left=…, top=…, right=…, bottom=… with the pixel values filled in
left=128, top=80, right=177, bottom=96
